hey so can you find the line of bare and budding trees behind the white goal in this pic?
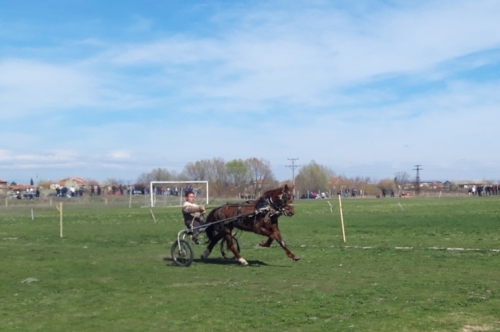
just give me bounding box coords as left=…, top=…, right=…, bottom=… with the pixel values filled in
left=128, top=158, right=410, bottom=197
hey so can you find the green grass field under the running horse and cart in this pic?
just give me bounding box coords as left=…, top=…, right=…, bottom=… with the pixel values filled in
left=0, top=197, right=500, bottom=331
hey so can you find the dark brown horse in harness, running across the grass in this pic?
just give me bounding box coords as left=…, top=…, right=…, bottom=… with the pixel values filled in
left=201, top=185, right=299, bottom=266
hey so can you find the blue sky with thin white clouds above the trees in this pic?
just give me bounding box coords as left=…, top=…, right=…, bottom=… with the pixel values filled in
left=0, top=0, right=500, bottom=183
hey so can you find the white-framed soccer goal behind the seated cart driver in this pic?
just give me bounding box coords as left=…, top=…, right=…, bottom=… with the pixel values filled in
left=149, top=181, right=208, bottom=207
